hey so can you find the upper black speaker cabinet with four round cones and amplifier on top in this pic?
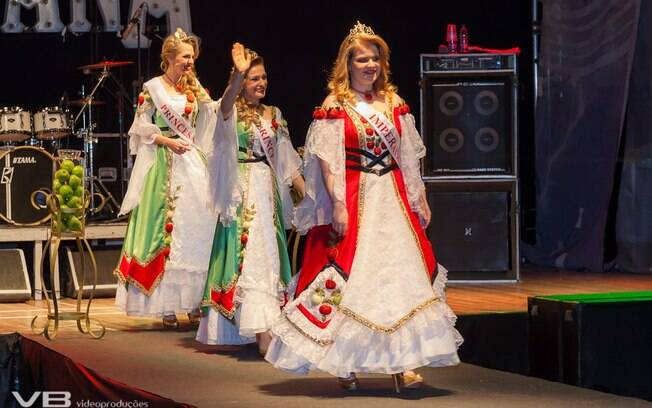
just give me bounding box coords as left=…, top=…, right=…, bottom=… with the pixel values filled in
left=421, top=54, right=518, bottom=177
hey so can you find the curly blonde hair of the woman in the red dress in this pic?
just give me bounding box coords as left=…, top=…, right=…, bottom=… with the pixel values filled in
left=328, top=33, right=397, bottom=101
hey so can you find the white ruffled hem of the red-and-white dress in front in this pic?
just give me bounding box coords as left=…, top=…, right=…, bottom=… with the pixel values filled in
left=265, top=266, right=463, bottom=377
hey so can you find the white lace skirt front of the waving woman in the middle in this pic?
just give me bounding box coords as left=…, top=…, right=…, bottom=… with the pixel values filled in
left=196, top=163, right=283, bottom=344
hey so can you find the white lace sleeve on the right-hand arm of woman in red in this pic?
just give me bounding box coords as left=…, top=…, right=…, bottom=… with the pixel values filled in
left=400, top=113, right=426, bottom=212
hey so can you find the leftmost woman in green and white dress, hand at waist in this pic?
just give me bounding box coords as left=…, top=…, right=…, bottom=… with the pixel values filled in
left=115, top=29, right=216, bottom=327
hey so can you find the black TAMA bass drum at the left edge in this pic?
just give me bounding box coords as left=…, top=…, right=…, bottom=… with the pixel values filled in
left=0, top=146, right=54, bottom=225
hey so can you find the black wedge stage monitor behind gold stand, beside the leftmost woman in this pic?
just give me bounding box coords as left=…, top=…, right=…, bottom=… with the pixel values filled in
left=62, top=245, right=122, bottom=297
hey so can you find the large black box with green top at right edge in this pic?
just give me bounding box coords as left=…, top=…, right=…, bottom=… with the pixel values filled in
left=528, top=291, right=652, bottom=400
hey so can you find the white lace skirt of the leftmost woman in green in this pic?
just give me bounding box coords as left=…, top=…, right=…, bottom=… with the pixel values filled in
left=115, top=151, right=216, bottom=317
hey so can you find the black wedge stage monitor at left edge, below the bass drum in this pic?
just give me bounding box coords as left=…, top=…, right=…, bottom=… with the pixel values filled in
left=0, top=249, right=32, bottom=302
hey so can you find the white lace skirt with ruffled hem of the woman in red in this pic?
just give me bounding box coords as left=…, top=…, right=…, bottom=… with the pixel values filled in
left=265, top=174, right=462, bottom=377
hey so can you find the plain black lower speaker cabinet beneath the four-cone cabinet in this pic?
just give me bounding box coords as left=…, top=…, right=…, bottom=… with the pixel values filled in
left=426, top=179, right=519, bottom=282
